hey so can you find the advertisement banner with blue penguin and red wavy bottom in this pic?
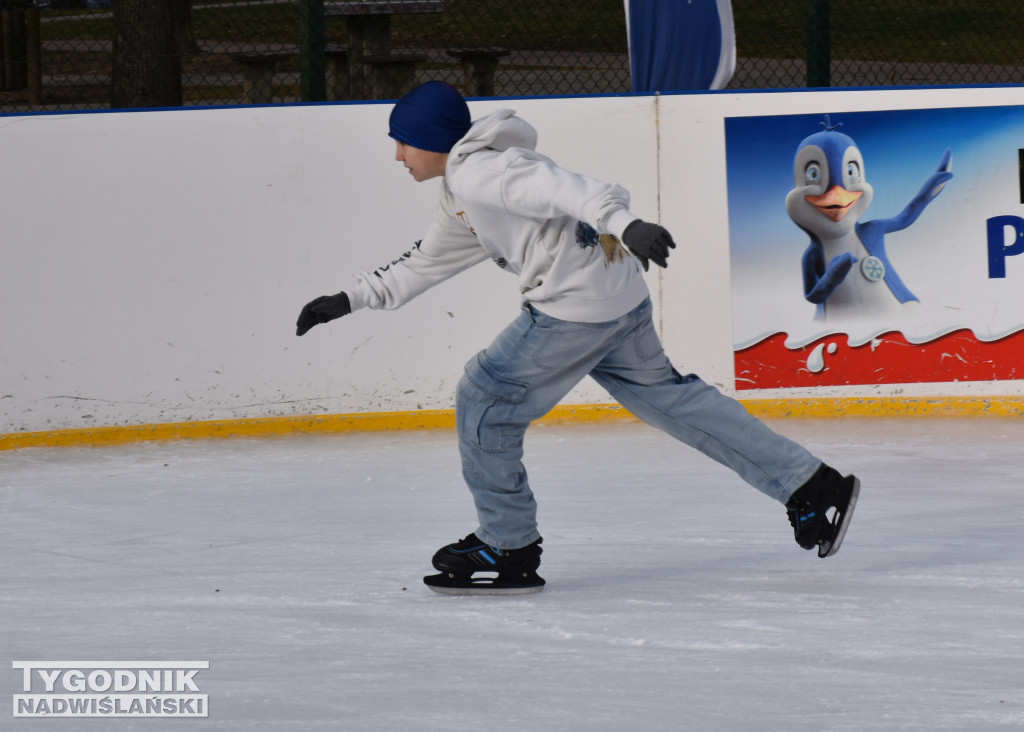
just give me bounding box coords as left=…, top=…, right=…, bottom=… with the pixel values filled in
left=725, top=106, right=1024, bottom=390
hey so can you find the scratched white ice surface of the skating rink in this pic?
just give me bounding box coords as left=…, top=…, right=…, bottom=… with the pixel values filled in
left=0, top=418, right=1024, bottom=732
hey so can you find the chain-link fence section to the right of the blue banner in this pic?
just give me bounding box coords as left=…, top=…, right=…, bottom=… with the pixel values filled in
left=729, top=0, right=1024, bottom=89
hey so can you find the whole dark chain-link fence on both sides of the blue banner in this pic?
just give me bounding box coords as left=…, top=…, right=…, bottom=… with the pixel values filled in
left=0, top=0, right=1024, bottom=113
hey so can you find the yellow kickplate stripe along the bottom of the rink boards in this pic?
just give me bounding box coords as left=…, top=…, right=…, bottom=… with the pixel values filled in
left=0, top=397, right=1024, bottom=451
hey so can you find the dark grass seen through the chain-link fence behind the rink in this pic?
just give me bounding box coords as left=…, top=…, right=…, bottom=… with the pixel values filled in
left=36, top=0, right=1024, bottom=64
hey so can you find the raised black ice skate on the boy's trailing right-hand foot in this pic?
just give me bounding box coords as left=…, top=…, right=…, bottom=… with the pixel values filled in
left=785, top=463, right=860, bottom=558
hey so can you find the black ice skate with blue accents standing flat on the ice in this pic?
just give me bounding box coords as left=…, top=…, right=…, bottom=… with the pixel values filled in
left=423, top=533, right=544, bottom=595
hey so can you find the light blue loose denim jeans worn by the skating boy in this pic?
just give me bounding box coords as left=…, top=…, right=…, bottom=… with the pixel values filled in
left=456, top=300, right=821, bottom=549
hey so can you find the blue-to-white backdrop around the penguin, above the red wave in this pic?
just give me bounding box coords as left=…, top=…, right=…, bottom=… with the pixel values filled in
left=725, top=106, right=1024, bottom=347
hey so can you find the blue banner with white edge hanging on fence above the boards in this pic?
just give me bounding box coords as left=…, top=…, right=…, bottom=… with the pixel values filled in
left=625, top=0, right=736, bottom=91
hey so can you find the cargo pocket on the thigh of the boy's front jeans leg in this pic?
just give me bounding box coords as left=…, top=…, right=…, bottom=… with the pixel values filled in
left=456, top=354, right=526, bottom=453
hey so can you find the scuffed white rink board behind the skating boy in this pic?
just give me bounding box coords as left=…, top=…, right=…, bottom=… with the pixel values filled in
left=0, top=87, right=1024, bottom=433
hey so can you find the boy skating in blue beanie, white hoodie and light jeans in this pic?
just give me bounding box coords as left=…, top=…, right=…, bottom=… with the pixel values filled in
left=296, top=82, right=859, bottom=594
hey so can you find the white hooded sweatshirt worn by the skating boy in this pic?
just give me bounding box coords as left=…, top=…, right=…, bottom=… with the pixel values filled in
left=346, top=110, right=649, bottom=322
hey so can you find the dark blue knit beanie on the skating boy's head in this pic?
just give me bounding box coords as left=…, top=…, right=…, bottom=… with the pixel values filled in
left=388, top=81, right=472, bottom=153
